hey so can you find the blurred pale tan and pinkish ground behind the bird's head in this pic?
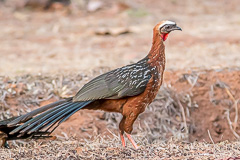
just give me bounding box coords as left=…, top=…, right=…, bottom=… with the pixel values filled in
left=0, top=0, right=240, bottom=75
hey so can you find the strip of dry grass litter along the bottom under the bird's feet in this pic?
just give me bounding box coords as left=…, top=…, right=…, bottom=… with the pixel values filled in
left=0, top=136, right=240, bottom=160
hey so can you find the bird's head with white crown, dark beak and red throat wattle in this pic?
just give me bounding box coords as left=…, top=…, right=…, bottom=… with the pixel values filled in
left=154, top=21, right=182, bottom=41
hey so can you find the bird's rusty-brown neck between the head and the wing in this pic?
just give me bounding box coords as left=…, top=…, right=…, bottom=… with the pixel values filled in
left=147, top=32, right=165, bottom=70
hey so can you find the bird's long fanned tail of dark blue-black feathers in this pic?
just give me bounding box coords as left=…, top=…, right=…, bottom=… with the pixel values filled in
left=0, top=98, right=92, bottom=140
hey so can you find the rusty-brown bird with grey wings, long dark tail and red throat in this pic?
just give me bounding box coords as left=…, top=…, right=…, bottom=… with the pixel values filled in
left=0, top=20, right=182, bottom=149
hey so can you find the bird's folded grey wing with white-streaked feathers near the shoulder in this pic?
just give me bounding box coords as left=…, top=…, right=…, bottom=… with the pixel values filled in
left=73, top=58, right=151, bottom=101
